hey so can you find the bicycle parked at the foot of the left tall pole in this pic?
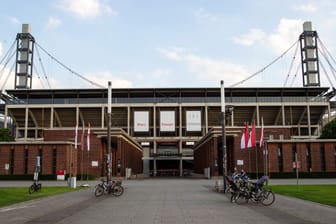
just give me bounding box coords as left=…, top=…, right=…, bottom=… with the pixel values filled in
left=94, top=179, right=124, bottom=197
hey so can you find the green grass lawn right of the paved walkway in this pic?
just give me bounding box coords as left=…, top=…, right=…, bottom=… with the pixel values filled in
left=267, top=185, right=336, bottom=206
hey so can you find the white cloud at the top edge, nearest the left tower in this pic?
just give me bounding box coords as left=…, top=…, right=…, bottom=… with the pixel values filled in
left=58, top=0, right=118, bottom=19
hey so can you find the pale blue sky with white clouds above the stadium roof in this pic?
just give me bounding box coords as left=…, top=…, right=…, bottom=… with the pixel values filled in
left=0, top=0, right=336, bottom=90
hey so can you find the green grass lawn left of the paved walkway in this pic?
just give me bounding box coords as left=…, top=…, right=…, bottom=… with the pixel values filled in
left=0, top=187, right=80, bottom=207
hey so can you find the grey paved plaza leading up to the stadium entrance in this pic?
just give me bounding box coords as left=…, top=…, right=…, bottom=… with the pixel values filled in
left=0, top=178, right=336, bottom=224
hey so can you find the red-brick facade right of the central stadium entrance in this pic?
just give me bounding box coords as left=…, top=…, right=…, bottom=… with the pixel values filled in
left=194, top=128, right=336, bottom=176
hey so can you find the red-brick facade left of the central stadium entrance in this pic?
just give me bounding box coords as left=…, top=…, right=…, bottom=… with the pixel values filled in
left=0, top=130, right=142, bottom=177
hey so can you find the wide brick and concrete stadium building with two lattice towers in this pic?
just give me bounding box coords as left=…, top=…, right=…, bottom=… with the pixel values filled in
left=0, top=22, right=336, bottom=180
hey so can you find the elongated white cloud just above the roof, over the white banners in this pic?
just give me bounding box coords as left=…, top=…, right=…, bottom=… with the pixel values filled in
left=158, top=48, right=249, bottom=84
